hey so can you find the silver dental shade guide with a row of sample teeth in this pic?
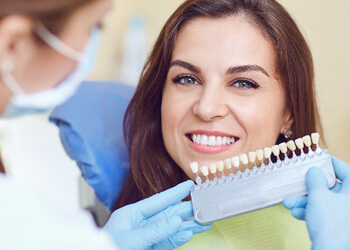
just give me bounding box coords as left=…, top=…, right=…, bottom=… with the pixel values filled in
left=191, top=133, right=336, bottom=224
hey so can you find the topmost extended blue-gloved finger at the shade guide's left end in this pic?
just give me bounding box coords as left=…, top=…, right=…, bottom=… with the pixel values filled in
left=135, top=180, right=194, bottom=218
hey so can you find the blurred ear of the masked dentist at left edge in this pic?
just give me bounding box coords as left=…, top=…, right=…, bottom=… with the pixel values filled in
left=0, top=15, right=34, bottom=65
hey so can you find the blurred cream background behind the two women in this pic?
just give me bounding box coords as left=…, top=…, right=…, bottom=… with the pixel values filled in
left=89, top=0, right=350, bottom=163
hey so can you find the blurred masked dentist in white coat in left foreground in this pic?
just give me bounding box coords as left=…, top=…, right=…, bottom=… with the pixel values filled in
left=0, top=0, right=209, bottom=249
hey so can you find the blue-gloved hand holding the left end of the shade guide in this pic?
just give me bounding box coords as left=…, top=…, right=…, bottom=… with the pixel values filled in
left=104, top=181, right=211, bottom=250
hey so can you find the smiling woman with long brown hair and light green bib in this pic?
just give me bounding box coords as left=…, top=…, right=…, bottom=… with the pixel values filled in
left=116, top=0, right=321, bottom=249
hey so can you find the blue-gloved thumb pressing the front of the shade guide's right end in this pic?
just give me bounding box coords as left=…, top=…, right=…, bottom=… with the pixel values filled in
left=306, top=167, right=328, bottom=192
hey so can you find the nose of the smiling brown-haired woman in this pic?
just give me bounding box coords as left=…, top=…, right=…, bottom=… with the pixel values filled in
left=193, top=88, right=229, bottom=121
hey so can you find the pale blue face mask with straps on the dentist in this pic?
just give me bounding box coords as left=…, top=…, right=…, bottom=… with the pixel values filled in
left=1, top=23, right=100, bottom=117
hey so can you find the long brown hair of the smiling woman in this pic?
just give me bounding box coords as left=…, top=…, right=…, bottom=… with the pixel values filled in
left=115, top=0, right=322, bottom=208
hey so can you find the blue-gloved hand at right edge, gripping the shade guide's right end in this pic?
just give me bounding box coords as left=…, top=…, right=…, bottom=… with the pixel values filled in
left=283, top=157, right=350, bottom=249
